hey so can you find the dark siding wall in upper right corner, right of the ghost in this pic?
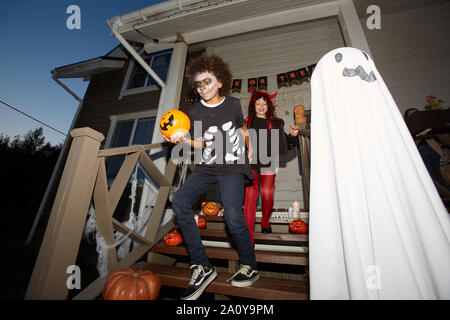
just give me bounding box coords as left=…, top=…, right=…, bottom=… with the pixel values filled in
left=361, top=2, right=450, bottom=113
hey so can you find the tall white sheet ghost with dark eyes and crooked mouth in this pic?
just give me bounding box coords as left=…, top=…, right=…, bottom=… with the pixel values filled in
left=309, top=48, right=450, bottom=299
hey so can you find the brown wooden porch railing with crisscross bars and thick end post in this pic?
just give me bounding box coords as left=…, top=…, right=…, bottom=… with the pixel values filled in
left=25, top=128, right=176, bottom=299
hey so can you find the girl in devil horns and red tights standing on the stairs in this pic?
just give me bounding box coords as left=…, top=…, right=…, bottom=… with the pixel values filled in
left=244, top=88, right=299, bottom=244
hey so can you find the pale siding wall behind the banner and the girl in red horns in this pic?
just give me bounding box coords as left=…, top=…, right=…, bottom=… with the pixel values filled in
left=203, top=18, right=344, bottom=208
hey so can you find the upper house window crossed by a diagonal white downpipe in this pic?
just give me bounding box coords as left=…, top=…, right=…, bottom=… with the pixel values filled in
left=127, top=49, right=172, bottom=90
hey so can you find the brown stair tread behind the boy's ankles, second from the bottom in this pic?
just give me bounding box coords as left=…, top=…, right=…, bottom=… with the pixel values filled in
left=151, top=242, right=308, bottom=266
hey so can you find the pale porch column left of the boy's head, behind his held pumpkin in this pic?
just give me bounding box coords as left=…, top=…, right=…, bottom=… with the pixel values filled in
left=151, top=39, right=188, bottom=172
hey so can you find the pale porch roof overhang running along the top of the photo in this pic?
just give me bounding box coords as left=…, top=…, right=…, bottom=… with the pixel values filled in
left=108, top=0, right=446, bottom=44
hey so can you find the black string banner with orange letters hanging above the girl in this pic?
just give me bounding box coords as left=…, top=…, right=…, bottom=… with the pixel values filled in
left=231, top=64, right=316, bottom=93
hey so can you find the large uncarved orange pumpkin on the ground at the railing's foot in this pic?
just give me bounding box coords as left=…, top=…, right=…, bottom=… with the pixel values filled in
left=103, top=268, right=161, bottom=300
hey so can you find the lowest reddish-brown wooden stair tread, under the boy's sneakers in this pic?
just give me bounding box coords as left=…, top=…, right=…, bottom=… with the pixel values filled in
left=147, top=264, right=309, bottom=300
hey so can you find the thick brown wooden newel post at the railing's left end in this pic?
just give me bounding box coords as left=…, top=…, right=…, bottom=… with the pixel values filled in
left=25, top=128, right=104, bottom=300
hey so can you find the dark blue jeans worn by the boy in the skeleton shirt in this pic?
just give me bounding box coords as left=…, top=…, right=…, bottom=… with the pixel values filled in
left=172, top=172, right=257, bottom=269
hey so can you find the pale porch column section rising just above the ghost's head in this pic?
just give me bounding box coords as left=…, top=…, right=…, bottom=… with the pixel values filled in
left=338, top=0, right=372, bottom=57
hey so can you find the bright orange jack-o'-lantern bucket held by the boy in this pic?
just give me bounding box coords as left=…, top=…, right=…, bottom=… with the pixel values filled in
left=159, top=109, right=191, bottom=139
